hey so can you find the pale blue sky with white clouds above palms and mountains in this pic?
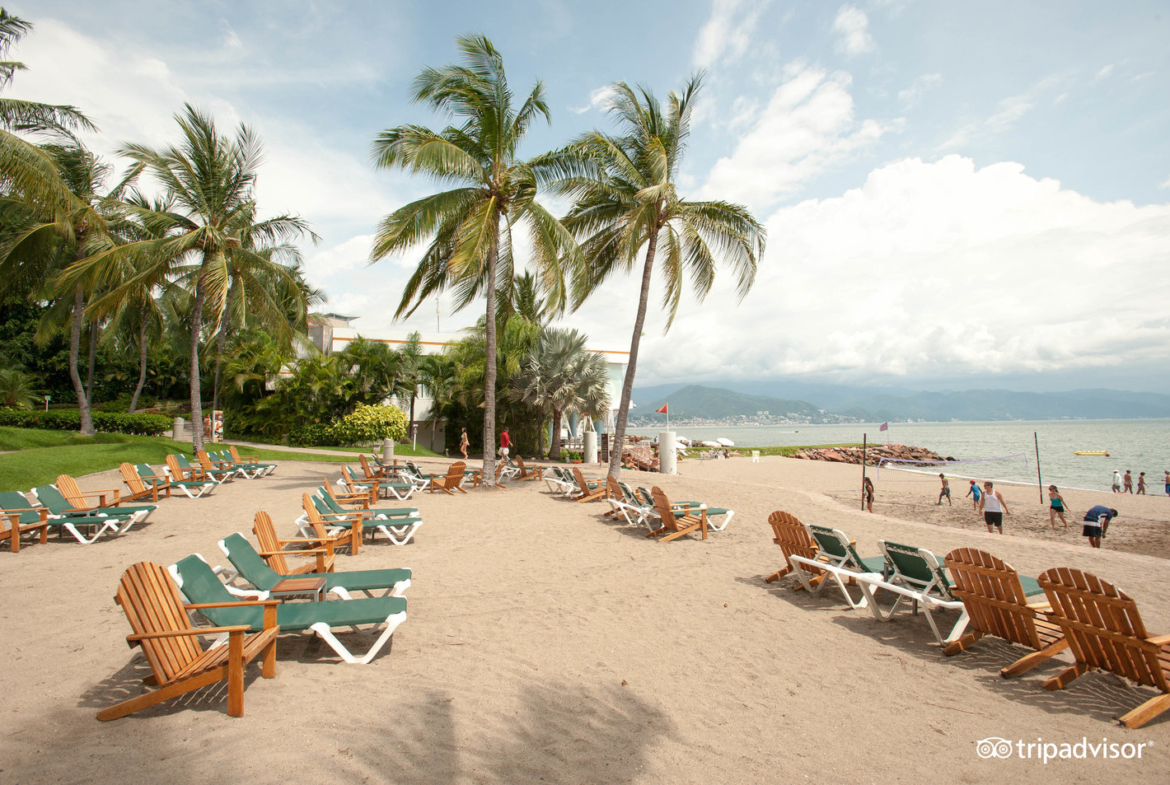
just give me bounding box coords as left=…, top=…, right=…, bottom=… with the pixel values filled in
left=8, top=0, right=1170, bottom=390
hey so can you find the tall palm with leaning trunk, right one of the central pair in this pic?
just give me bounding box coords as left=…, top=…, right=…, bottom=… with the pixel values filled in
left=534, top=75, right=765, bottom=477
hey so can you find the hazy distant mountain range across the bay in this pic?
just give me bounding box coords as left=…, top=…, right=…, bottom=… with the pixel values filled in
left=633, top=381, right=1170, bottom=422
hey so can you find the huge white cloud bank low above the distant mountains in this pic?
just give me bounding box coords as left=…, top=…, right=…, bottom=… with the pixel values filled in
left=613, top=156, right=1170, bottom=386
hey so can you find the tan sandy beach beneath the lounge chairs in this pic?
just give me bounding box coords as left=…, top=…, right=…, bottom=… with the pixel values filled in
left=0, top=457, right=1170, bottom=785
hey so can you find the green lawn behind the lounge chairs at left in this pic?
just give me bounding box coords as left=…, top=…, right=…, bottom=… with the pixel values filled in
left=0, top=427, right=434, bottom=490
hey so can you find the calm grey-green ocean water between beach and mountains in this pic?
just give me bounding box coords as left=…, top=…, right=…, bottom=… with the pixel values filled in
left=629, top=420, right=1170, bottom=496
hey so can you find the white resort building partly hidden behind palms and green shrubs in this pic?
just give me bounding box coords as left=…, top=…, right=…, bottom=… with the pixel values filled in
left=309, top=314, right=629, bottom=453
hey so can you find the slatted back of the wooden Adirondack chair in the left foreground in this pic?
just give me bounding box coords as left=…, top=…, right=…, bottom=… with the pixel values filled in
left=115, top=562, right=202, bottom=684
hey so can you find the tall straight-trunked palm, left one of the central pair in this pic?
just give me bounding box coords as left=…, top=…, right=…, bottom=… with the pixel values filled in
left=371, top=35, right=580, bottom=484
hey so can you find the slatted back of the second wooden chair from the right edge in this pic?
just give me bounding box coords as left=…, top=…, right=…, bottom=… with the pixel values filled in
left=945, top=548, right=1042, bottom=650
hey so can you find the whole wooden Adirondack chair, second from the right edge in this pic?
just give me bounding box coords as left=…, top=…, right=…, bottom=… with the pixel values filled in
left=943, top=548, right=1068, bottom=677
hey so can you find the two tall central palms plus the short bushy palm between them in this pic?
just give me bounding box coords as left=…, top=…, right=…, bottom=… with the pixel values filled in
left=371, top=35, right=765, bottom=477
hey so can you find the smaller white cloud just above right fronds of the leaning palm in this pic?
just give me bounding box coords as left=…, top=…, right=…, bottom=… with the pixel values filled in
left=702, top=63, right=892, bottom=207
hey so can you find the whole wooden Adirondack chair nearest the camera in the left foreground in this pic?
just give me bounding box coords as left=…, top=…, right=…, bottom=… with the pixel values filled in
left=97, top=562, right=280, bottom=721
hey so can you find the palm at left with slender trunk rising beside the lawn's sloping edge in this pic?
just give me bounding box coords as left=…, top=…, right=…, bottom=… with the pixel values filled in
left=76, top=104, right=317, bottom=449
